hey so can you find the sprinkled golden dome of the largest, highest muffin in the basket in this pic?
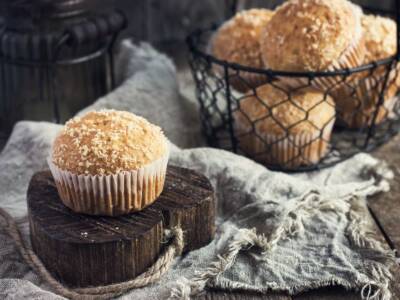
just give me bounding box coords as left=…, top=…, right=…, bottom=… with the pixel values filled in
left=261, top=0, right=362, bottom=72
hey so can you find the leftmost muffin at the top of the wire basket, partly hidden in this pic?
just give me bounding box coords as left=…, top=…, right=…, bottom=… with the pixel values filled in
left=210, top=9, right=273, bottom=92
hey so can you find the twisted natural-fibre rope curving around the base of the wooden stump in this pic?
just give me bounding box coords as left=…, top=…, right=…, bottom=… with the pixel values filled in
left=0, top=208, right=184, bottom=300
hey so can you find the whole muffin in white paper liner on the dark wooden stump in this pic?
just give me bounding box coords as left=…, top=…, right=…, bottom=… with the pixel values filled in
left=48, top=110, right=169, bottom=216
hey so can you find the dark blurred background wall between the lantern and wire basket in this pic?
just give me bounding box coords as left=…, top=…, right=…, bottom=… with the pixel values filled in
left=107, top=0, right=395, bottom=43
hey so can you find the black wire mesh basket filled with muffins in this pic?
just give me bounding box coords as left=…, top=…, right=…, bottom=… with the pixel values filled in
left=187, top=1, right=400, bottom=172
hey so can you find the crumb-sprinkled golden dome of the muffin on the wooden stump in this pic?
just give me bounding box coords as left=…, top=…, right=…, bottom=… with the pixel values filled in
left=52, top=110, right=168, bottom=175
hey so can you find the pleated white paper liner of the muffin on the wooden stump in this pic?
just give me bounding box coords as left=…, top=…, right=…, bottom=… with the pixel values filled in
left=47, top=151, right=169, bottom=216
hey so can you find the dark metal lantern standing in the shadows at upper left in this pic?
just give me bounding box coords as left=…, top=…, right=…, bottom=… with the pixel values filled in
left=0, top=0, right=125, bottom=136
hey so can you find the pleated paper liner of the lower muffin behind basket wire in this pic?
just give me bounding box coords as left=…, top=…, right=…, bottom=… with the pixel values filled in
left=237, top=120, right=335, bottom=169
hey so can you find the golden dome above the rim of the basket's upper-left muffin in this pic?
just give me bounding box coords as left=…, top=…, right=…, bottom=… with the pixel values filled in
left=212, top=9, right=273, bottom=68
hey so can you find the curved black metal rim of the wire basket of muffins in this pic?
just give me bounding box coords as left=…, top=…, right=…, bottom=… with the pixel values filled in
left=186, top=24, right=399, bottom=79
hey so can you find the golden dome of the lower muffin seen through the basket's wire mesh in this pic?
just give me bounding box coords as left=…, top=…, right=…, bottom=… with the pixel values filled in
left=234, top=84, right=335, bottom=134
